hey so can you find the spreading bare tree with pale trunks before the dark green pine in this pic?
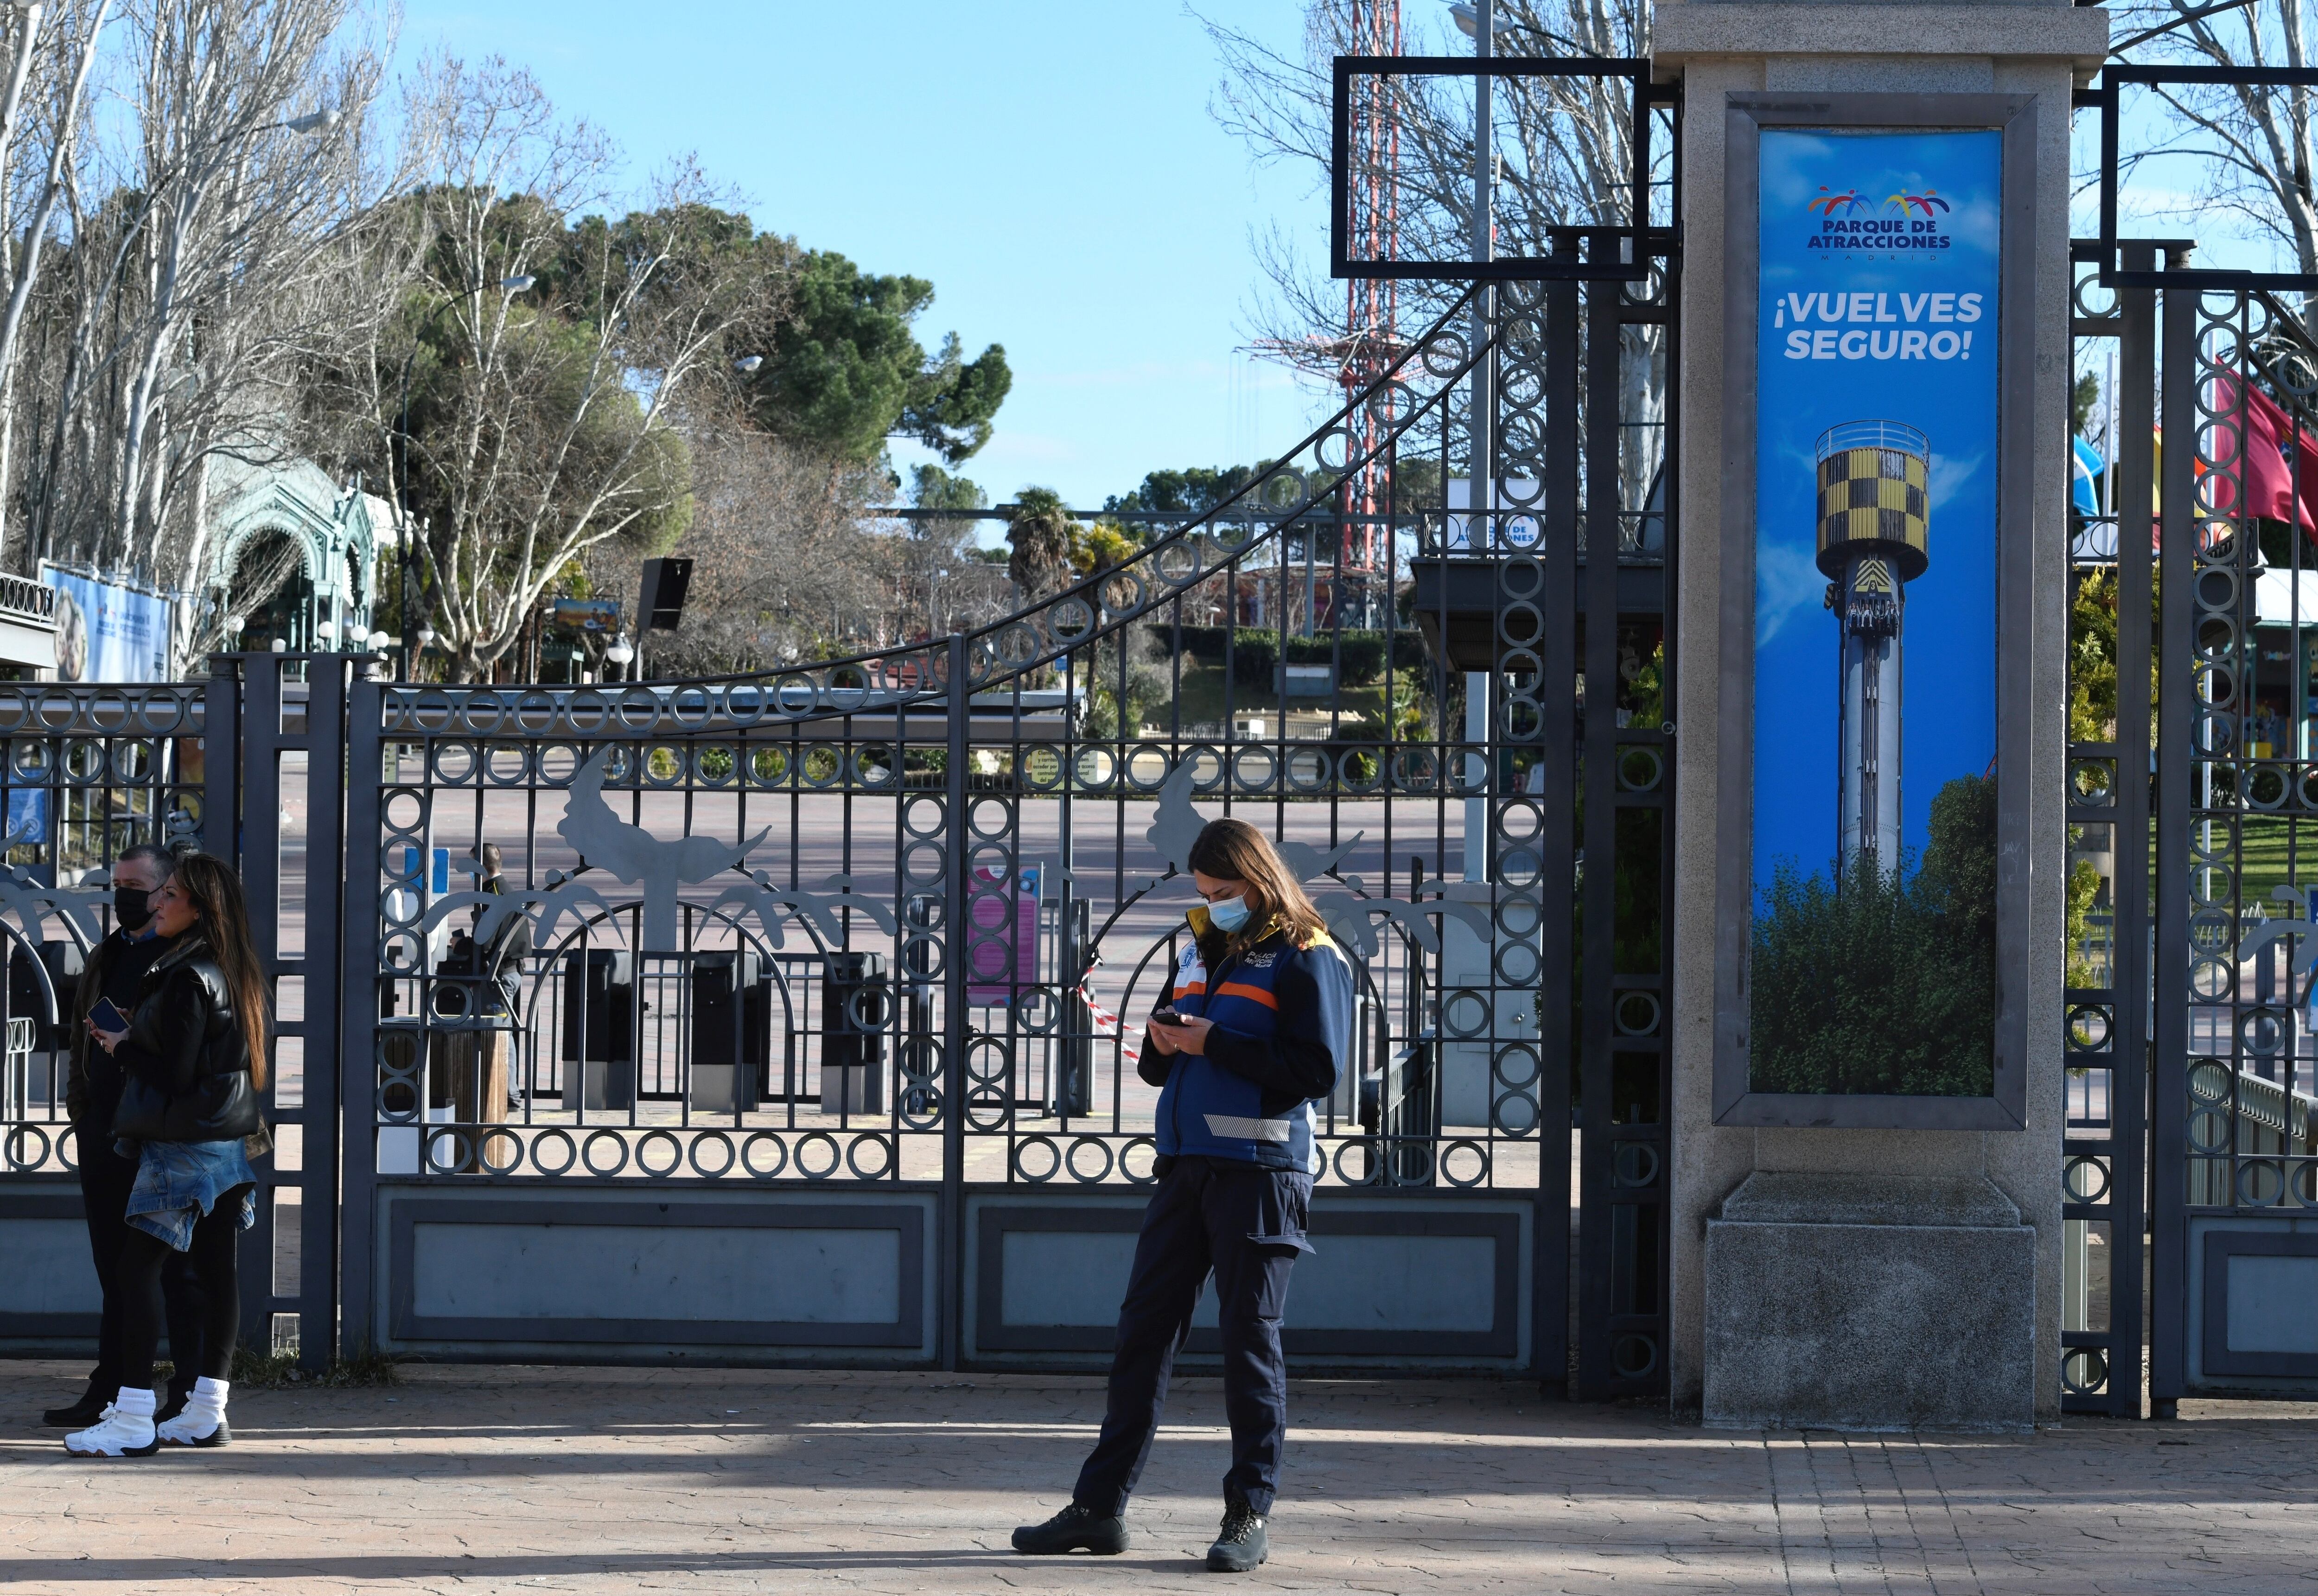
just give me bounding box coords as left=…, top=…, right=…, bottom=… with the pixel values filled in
left=396, top=60, right=779, bottom=681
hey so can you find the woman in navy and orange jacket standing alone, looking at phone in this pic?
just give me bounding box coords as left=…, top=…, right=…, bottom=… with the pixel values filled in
left=1013, top=820, right=1354, bottom=1573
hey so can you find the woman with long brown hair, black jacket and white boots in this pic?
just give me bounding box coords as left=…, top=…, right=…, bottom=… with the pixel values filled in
left=65, top=852, right=269, bottom=1457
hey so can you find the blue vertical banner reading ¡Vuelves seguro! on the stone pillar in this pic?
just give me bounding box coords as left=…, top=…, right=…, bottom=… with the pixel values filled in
left=1750, top=127, right=2003, bottom=1096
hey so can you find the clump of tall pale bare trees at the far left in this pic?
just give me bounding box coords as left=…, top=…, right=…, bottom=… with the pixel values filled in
left=7, top=0, right=401, bottom=672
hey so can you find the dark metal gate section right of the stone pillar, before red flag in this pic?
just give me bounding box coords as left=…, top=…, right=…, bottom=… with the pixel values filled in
left=2063, top=241, right=2318, bottom=1415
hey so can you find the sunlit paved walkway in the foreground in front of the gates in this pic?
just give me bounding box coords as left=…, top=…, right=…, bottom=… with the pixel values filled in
left=0, top=1362, right=2318, bottom=1596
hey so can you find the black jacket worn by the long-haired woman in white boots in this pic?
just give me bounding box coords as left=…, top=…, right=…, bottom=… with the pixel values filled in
left=114, top=931, right=262, bottom=1142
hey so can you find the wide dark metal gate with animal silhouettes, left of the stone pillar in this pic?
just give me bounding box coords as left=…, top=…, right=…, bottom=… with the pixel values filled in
left=0, top=63, right=1678, bottom=1397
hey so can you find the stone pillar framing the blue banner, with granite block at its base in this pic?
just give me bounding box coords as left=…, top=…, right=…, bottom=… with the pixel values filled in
left=1653, top=0, right=2107, bottom=1427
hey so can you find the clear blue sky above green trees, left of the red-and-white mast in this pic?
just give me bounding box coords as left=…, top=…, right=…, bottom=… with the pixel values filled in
left=401, top=0, right=1344, bottom=535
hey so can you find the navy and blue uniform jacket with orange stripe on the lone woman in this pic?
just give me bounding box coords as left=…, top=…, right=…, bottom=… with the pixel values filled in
left=1140, top=908, right=1354, bottom=1175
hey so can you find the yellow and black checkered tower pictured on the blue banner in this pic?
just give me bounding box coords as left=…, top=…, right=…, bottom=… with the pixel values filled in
left=1817, top=421, right=1931, bottom=871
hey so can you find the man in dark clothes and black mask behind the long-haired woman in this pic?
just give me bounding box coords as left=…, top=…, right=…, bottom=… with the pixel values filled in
left=42, top=843, right=202, bottom=1429
